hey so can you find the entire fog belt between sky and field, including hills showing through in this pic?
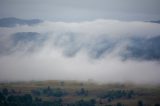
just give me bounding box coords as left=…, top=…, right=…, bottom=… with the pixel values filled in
left=0, top=19, right=160, bottom=83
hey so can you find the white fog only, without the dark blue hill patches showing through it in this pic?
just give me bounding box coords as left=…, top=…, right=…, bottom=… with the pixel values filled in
left=0, top=20, right=160, bottom=83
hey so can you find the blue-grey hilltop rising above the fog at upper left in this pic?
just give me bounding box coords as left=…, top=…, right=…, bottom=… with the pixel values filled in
left=0, top=17, right=42, bottom=27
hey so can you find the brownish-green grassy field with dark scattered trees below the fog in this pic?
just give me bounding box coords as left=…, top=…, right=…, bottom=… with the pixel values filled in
left=0, top=80, right=160, bottom=106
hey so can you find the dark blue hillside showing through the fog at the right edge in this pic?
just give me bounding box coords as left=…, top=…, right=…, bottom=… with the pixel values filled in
left=123, top=36, right=160, bottom=60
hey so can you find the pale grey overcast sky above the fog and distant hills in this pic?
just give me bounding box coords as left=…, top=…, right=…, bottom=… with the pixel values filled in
left=0, top=0, right=160, bottom=21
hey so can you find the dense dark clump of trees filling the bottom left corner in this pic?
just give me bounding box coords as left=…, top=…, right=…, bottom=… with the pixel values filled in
left=0, top=88, right=62, bottom=106
